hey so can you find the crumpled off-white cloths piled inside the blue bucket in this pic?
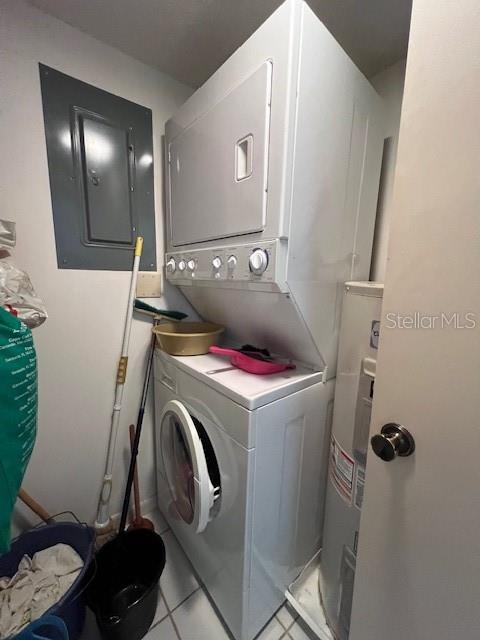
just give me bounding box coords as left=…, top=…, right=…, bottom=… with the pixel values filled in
left=0, top=544, right=83, bottom=640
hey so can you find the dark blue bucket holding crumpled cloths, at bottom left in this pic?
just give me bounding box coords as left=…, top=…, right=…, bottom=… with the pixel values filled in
left=0, top=522, right=95, bottom=640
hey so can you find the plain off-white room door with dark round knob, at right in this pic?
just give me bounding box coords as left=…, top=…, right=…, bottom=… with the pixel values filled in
left=350, top=0, right=480, bottom=640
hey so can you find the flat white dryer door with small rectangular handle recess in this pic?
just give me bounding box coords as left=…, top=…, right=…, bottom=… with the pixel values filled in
left=168, top=61, right=272, bottom=247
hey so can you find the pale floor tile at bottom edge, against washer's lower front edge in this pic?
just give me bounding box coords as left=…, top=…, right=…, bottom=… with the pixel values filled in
left=172, top=589, right=229, bottom=640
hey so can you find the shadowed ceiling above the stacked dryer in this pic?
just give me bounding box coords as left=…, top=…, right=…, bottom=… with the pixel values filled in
left=29, top=0, right=411, bottom=87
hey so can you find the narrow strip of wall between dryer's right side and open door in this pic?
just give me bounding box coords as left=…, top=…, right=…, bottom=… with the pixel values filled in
left=370, top=60, right=406, bottom=282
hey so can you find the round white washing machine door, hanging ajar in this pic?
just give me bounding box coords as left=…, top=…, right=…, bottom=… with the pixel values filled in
left=160, top=400, right=220, bottom=533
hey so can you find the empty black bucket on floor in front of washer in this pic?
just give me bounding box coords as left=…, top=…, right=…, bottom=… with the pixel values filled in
left=87, top=529, right=165, bottom=640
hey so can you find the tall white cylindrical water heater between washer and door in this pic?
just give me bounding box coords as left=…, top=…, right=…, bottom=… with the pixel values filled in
left=319, top=282, right=383, bottom=640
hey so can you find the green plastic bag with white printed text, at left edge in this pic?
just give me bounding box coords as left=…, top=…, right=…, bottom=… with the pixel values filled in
left=0, top=308, right=38, bottom=553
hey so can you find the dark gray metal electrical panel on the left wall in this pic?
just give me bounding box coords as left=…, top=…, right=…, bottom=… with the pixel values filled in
left=39, top=64, right=156, bottom=271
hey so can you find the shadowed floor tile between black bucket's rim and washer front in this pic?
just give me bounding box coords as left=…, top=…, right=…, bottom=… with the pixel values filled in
left=160, top=531, right=199, bottom=611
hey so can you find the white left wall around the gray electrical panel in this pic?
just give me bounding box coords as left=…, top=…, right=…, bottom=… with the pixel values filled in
left=0, top=0, right=195, bottom=520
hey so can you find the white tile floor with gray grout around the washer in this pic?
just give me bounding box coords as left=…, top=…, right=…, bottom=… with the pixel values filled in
left=81, top=512, right=315, bottom=640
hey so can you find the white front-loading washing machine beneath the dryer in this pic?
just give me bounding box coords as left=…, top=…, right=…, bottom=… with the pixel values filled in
left=154, top=350, right=333, bottom=640
